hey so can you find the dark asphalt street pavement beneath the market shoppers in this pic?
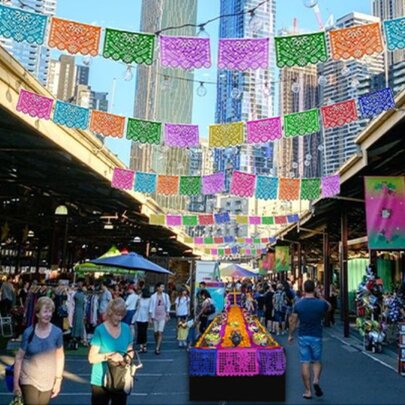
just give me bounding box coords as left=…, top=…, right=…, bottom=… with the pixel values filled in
left=0, top=320, right=405, bottom=405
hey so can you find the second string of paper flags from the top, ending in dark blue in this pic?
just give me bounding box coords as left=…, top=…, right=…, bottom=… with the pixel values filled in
left=16, top=85, right=394, bottom=149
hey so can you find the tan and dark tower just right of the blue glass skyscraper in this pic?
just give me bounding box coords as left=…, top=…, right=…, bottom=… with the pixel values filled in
left=276, top=65, right=321, bottom=177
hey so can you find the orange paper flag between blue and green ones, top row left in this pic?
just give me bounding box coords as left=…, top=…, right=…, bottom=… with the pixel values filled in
left=48, top=17, right=101, bottom=56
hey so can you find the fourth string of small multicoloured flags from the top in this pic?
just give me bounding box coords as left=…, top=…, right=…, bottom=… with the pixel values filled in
left=149, top=212, right=299, bottom=227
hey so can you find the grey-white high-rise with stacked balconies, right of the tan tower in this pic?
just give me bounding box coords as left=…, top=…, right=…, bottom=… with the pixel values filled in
left=318, top=13, right=384, bottom=174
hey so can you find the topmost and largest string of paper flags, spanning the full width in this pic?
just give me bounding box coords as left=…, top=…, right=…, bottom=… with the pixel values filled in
left=0, top=5, right=405, bottom=71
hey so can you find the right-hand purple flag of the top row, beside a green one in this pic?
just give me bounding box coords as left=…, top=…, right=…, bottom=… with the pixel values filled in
left=218, top=38, right=269, bottom=70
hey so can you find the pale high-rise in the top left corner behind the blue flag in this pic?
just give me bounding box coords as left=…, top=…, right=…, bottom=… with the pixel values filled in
left=0, top=0, right=57, bottom=85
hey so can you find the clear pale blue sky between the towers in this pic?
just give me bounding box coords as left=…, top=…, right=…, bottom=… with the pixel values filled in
left=52, top=0, right=372, bottom=165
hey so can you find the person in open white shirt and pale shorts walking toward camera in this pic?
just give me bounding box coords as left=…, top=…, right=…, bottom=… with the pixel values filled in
left=149, top=283, right=170, bottom=354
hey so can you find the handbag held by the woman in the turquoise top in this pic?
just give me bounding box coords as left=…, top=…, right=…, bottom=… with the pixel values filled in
left=103, top=352, right=142, bottom=395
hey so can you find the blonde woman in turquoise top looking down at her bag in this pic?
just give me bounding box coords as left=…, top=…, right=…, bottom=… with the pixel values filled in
left=89, top=298, right=132, bottom=405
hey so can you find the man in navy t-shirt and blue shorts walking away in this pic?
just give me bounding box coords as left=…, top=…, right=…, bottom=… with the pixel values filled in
left=288, top=280, right=330, bottom=399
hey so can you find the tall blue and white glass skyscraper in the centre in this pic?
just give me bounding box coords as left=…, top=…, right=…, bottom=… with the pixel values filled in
left=214, top=0, right=276, bottom=236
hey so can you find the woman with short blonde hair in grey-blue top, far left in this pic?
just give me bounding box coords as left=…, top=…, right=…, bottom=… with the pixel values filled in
left=14, top=297, right=65, bottom=405
